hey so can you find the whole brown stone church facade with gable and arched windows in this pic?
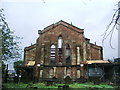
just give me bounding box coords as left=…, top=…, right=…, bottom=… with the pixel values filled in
left=24, top=20, right=103, bottom=80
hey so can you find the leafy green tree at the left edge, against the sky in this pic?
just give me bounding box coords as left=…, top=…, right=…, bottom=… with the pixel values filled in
left=0, top=9, right=21, bottom=61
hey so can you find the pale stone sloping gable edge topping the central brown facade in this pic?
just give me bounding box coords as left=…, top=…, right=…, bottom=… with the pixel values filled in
left=41, top=20, right=84, bottom=33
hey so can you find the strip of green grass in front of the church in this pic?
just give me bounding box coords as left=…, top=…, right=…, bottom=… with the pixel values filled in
left=3, top=82, right=115, bottom=89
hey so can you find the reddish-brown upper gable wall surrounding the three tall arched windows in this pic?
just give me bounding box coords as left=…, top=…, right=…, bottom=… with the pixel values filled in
left=37, top=25, right=84, bottom=65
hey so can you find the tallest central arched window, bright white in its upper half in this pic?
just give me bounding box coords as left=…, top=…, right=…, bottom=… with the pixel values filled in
left=58, top=35, right=63, bottom=62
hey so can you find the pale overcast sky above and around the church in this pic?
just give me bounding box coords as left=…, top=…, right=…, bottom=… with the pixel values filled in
left=0, top=0, right=118, bottom=64
